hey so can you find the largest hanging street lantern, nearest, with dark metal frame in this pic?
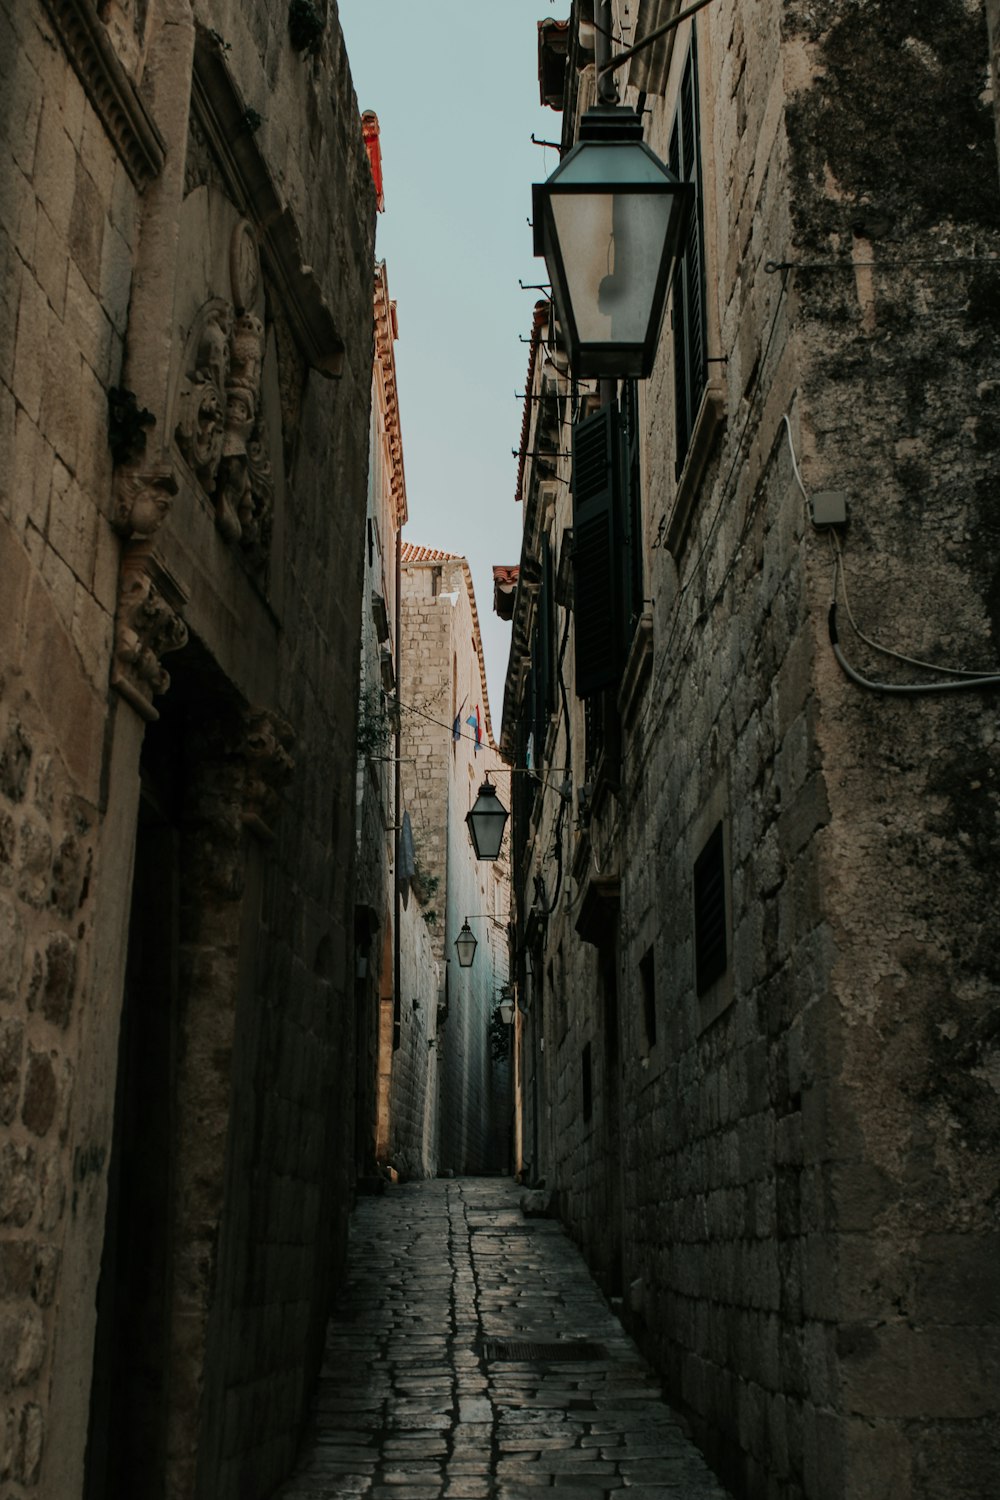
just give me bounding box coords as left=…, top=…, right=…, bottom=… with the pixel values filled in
left=532, top=105, right=694, bottom=380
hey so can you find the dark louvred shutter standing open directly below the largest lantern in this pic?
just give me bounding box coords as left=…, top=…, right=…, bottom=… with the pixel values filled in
left=573, top=407, right=619, bottom=698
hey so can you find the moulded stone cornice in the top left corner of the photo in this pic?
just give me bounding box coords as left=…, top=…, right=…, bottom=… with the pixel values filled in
left=43, top=0, right=166, bottom=192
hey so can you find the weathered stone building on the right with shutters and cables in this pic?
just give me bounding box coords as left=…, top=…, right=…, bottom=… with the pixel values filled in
left=501, top=0, right=1000, bottom=1500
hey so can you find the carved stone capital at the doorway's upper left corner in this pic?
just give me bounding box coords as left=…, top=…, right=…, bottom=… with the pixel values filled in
left=111, top=540, right=187, bottom=720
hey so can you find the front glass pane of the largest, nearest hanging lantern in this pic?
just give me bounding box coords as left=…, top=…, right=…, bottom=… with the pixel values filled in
left=552, top=192, right=672, bottom=344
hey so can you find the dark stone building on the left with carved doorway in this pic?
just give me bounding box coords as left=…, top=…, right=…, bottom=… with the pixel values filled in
left=0, top=0, right=375, bottom=1500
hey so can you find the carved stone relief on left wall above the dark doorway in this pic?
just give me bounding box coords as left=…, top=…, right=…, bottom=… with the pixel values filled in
left=174, top=219, right=274, bottom=567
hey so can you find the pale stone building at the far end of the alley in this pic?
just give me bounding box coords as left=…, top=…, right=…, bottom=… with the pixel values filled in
left=399, top=543, right=513, bottom=1173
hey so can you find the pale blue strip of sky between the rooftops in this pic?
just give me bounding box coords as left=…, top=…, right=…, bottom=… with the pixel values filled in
left=339, top=0, right=554, bottom=735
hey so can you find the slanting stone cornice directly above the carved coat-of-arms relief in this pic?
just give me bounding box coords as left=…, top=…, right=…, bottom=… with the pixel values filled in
left=192, top=26, right=343, bottom=377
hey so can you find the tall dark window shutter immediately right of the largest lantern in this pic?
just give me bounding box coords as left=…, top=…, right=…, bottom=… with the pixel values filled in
left=670, top=33, right=708, bottom=477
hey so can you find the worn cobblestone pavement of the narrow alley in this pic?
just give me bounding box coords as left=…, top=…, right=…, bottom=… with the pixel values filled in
left=274, top=1178, right=726, bottom=1500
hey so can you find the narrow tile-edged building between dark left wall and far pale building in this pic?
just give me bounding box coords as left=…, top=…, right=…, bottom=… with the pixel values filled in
left=355, top=258, right=439, bottom=1178
